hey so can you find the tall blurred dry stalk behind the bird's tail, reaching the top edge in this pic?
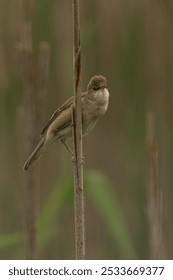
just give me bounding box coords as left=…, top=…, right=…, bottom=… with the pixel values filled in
left=18, top=0, right=38, bottom=259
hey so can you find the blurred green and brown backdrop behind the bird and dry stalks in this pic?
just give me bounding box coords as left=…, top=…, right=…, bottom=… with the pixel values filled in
left=0, top=0, right=173, bottom=259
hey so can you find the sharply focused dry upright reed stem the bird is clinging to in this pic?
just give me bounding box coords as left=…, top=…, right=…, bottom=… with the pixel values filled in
left=72, top=0, right=85, bottom=260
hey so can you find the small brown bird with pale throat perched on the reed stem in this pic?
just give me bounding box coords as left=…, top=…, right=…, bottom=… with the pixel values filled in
left=23, top=75, right=109, bottom=170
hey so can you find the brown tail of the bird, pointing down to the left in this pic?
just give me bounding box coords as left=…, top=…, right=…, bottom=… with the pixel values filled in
left=23, top=138, right=45, bottom=171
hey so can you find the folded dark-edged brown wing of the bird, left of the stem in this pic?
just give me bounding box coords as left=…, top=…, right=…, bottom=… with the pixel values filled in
left=41, top=96, right=74, bottom=135
